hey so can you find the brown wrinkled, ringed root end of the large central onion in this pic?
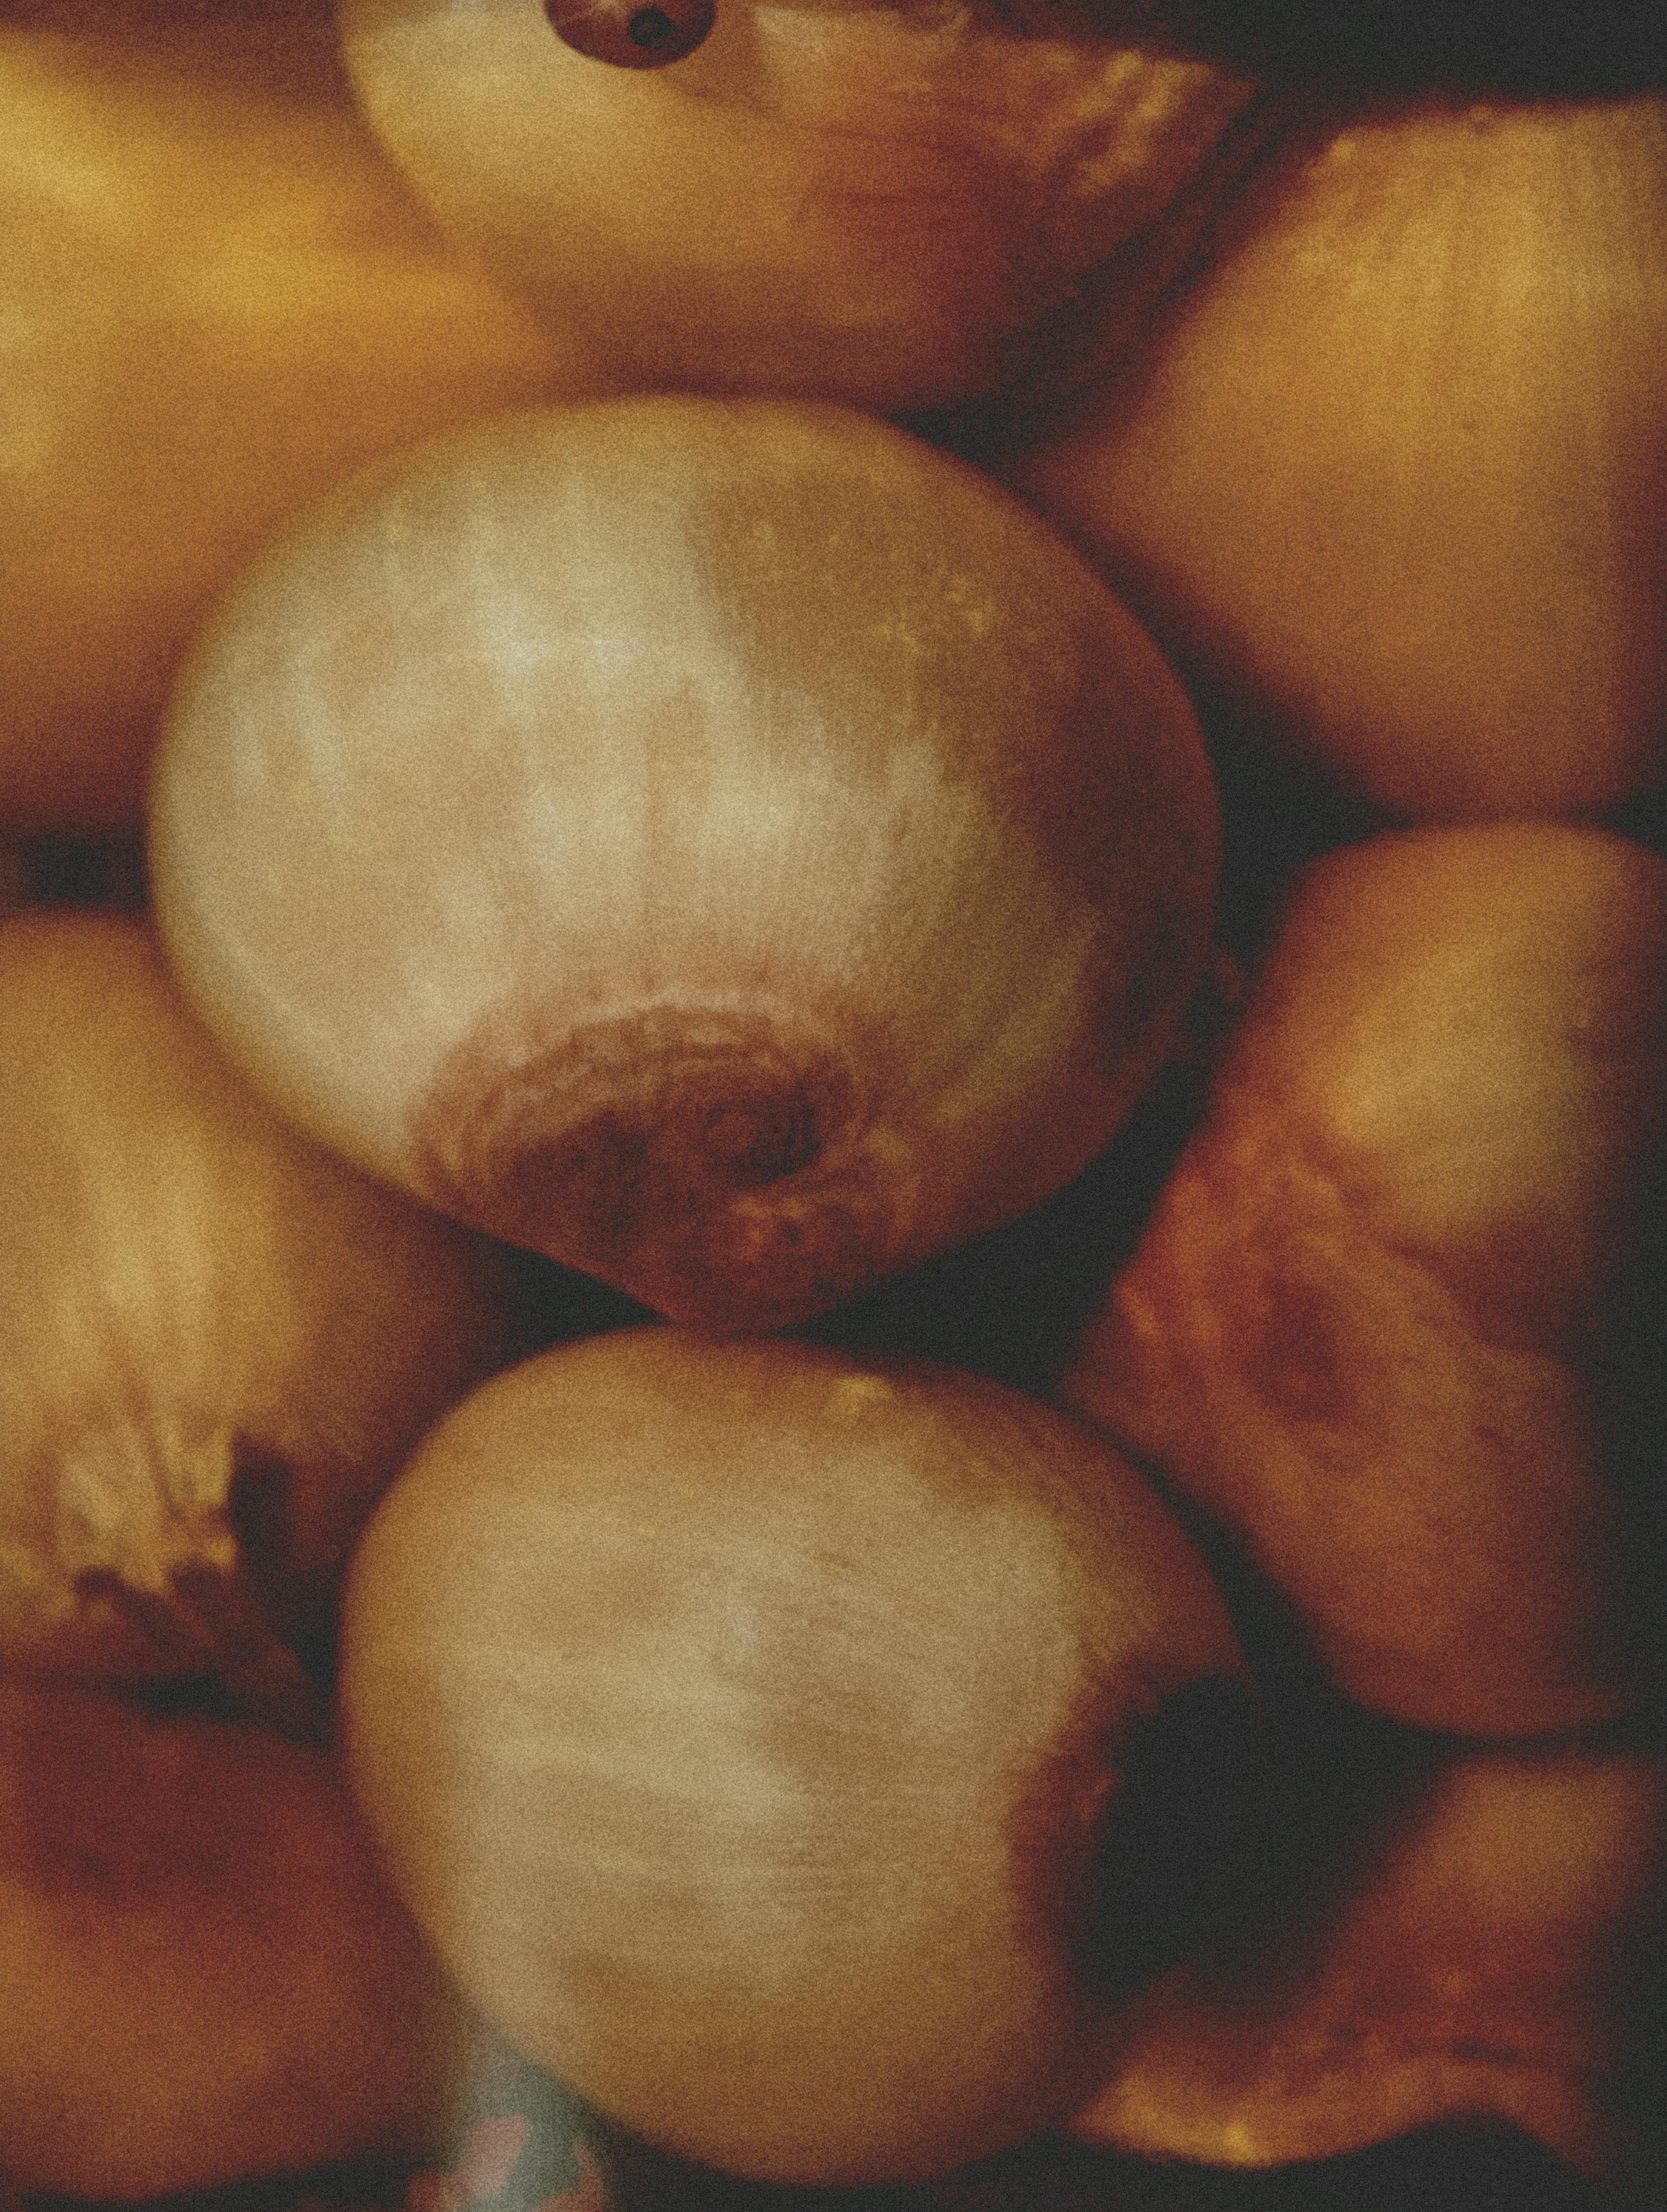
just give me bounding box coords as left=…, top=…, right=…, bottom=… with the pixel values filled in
left=412, top=1007, right=914, bottom=1329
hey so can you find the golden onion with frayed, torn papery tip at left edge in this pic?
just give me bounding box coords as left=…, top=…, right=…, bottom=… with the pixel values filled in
left=0, top=914, right=512, bottom=1690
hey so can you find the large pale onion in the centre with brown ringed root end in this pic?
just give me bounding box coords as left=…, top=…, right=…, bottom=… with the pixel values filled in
left=150, top=398, right=1218, bottom=1332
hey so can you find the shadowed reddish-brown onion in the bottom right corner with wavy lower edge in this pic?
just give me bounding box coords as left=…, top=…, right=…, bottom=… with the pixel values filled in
left=1074, top=1745, right=1667, bottom=2179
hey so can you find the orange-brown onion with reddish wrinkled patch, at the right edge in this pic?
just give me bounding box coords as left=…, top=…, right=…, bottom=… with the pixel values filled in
left=1063, top=823, right=1667, bottom=1736
